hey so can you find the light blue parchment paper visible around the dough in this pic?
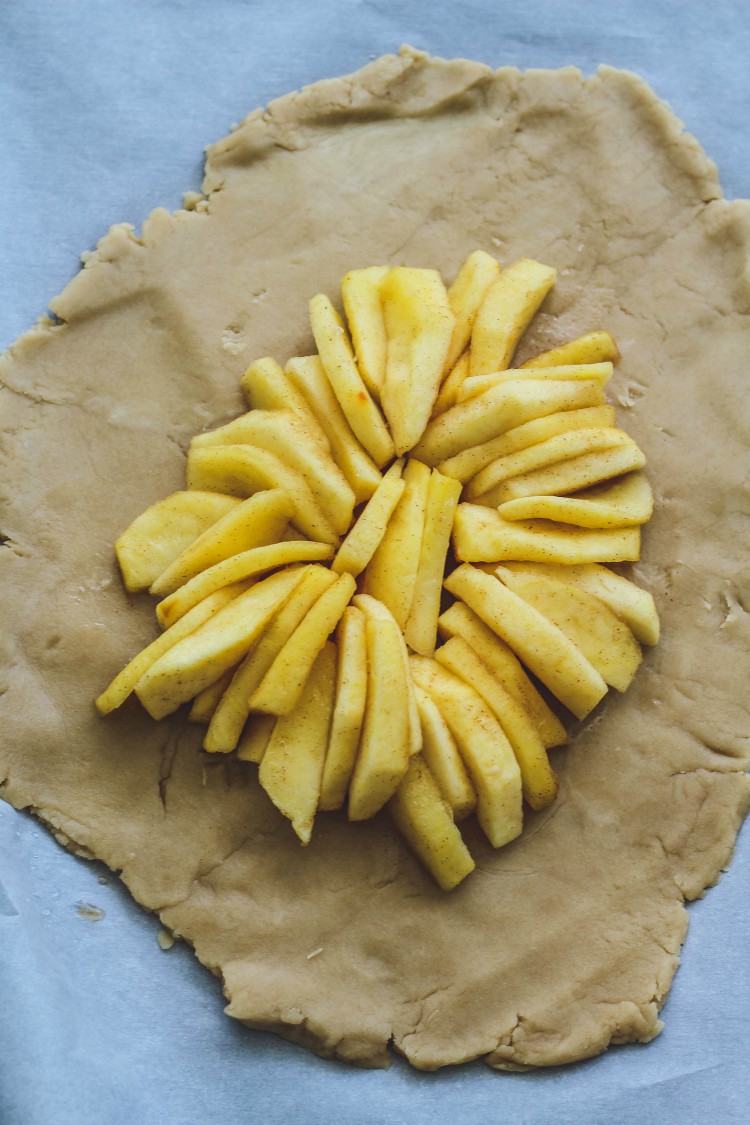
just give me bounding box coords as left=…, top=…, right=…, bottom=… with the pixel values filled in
left=0, top=0, right=750, bottom=1125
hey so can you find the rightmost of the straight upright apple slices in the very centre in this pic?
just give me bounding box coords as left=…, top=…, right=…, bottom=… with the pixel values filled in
left=404, top=469, right=461, bottom=656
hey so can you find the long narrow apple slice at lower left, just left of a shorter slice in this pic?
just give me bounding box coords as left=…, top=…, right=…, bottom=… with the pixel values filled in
left=204, top=566, right=336, bottom=761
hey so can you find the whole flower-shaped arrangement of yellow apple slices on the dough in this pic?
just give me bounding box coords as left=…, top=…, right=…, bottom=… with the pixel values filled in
left=97, top=251, right=659, bottom=890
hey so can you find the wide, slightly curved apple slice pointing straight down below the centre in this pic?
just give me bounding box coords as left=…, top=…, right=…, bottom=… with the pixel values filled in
left=347, top=618, right=410, bottom=820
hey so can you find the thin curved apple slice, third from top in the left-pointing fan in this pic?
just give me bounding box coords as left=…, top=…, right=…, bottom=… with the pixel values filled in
left=156, top=539, right=333, bottom=628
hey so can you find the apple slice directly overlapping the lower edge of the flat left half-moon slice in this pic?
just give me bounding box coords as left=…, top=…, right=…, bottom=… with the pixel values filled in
left=150, top=488, right=295, bottom=597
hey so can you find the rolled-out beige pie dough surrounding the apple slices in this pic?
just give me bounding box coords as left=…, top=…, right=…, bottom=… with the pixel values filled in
left=0, top=48, right=750, bottom=1068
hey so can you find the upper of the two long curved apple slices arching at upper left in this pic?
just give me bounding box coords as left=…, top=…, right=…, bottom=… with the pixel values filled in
left=191, top=410, right=354, bottom=534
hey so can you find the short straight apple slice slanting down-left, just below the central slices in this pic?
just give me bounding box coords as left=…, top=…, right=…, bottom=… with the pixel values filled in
left=250, top=574, right=356, bottom=714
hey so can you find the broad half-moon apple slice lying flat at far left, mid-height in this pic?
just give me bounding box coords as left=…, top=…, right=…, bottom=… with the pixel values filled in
left=115, top=491, right=240, bottom=594
